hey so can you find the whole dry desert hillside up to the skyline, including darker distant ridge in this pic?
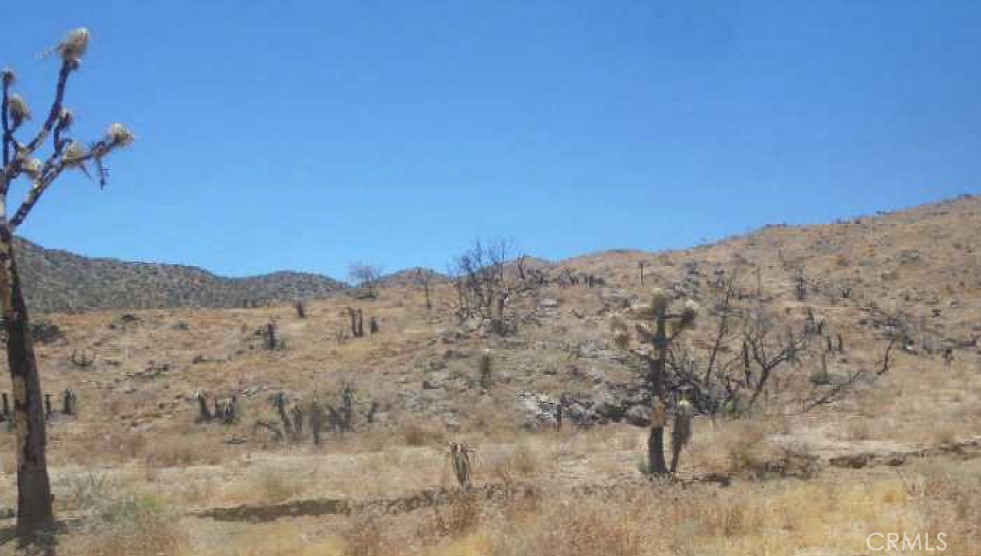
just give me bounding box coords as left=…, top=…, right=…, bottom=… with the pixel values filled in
left=0, top=193, right=981, bottom=556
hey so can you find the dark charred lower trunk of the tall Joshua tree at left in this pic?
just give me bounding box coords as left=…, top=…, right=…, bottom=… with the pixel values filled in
left=0, top=227, right=54, bottom=545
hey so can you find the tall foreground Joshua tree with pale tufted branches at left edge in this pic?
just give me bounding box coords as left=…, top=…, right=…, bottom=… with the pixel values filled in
left=0, top=29, right=133, bottom=545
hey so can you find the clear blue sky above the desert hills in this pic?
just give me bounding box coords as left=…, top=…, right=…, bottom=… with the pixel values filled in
left=0, top=0, right=981, bottom=277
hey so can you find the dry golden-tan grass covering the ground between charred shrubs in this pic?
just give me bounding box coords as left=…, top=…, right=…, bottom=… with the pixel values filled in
left=7, top=201, right=981, bottom=556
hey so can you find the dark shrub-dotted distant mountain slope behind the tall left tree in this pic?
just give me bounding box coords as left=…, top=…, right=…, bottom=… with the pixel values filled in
left=17, top=239, right=346, bottom=312
